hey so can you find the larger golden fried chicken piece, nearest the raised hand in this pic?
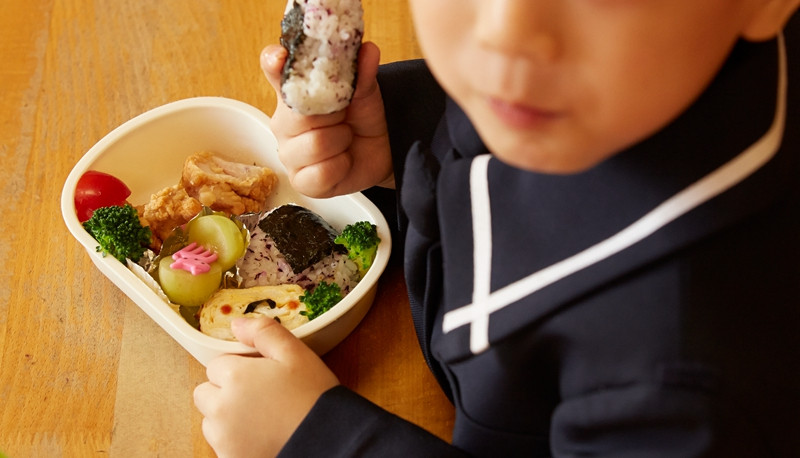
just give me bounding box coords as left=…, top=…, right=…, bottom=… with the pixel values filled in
left=181, top=151, right=278, bottom=215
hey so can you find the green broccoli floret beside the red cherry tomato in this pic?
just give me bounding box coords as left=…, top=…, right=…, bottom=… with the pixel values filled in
left=83, top=203, right=151, bottom=263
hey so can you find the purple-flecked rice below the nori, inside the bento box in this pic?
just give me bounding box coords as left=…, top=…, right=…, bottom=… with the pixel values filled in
left=237, top=222, right=358, bottom=297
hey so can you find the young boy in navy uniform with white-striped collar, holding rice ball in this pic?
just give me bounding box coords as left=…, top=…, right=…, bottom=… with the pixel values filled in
left=195, top=0, right=800, bottom=457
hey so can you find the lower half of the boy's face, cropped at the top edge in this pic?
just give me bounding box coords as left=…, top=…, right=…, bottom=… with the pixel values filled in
left=411, top=0, right=772, bottom=173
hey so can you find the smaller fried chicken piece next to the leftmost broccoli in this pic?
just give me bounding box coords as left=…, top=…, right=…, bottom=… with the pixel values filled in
left=139, top=185, right=203, bottom=252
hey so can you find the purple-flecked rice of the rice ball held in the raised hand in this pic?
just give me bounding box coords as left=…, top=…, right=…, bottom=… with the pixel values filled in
left=281, top=0, right=364, bottom=115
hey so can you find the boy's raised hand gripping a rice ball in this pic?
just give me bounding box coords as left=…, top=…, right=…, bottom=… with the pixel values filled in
left=261, top=42, right=394, bottom=197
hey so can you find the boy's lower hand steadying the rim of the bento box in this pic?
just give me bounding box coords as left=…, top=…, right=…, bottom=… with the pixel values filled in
left=194, top=318, right=339, bottom=457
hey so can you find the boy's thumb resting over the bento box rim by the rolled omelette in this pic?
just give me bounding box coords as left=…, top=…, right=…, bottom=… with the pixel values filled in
left=231, top=317, right=308, bottom=360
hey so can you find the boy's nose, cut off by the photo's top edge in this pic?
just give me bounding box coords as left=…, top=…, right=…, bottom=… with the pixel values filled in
left=475, top=0, right=563, bottom=61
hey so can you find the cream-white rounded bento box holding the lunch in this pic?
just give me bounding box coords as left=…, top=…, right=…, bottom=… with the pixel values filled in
left=61, top=97, right=391, bottom=365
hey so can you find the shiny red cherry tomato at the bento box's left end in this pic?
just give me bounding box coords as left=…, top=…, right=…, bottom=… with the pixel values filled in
left=75, top=170, right=131, bottom=222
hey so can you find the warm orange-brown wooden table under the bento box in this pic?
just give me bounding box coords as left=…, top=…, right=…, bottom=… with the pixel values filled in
left=0, top=0, right=453, bottom=457
